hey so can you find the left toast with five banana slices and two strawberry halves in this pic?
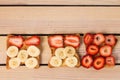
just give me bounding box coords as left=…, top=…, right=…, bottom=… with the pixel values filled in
left=6, top=35, right=41, bottom=69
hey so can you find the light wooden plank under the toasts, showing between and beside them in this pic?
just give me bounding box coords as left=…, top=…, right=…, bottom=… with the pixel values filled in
left=0, top=36, right=120, bottom=64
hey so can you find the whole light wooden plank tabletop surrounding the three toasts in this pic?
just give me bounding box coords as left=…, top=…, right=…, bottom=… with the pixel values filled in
left=0, top=0, right=120, bottom=80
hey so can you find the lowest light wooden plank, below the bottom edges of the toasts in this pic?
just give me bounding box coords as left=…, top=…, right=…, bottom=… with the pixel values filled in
left=0, top=66, right=120, bottom=80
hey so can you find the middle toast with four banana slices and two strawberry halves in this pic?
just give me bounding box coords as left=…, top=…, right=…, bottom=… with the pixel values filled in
left=48, top=34, right=80, bottom=68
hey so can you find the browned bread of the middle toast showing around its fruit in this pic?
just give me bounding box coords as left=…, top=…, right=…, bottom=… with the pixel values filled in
left=48, top=34, right=80, bottom=68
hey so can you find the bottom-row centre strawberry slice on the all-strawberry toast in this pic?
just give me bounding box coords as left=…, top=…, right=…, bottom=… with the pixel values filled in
left=93, top=56, right=105, bottom=70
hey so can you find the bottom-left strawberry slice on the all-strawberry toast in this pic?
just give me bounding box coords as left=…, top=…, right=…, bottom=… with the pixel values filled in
left=81, top=55, right=93, bottom=68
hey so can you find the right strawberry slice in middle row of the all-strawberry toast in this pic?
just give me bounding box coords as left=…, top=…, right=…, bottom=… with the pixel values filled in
left=100, top=45, right=112, bottom=57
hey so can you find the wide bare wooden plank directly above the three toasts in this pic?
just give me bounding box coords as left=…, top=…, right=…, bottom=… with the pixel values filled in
left=0, top=7, right=120, bottom=34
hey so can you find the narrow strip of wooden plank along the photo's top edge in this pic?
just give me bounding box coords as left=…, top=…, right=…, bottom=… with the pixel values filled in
left=0, top=0, right=120, bottom=5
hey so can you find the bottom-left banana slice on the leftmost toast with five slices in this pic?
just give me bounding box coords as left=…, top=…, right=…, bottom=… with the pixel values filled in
left=9, top=58, right=20, bottom=69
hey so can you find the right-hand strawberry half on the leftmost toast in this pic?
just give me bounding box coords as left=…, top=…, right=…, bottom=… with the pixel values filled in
left=24, top=36, right=40, bottom=46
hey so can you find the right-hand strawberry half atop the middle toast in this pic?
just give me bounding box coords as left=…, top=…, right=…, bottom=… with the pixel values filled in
left=64, top=35, right=80, bottom=48
